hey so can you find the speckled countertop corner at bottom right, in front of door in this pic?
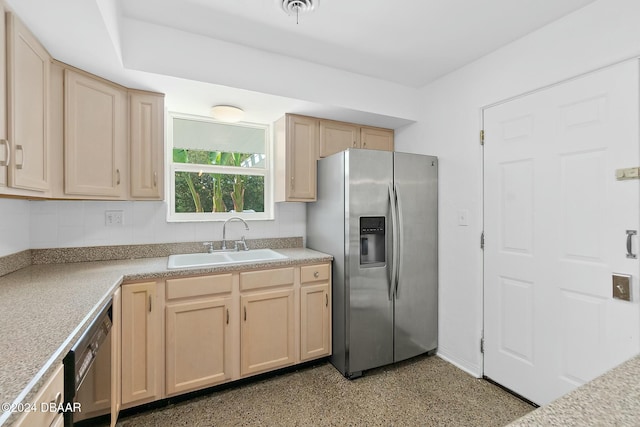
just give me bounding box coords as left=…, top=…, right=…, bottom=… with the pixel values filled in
left=509, top=355, right=640, bottom=427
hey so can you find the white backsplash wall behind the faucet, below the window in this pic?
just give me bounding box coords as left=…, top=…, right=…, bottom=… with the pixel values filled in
left=26, top=199, right=306, bottom=249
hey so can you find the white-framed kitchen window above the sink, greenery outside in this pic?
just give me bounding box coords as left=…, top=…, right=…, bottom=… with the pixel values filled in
left=167, top=113, right=273, bottom=221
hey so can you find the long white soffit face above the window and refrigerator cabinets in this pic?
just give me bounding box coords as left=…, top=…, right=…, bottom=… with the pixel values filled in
left=121, top=18, right=418, bottom=120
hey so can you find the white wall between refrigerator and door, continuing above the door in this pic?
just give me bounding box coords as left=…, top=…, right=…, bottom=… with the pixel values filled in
left=396, top=0, right=640, bottom=375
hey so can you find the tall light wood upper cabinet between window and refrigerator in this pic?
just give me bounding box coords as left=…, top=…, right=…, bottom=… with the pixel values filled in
left=274, top=114, right=320, bottom=202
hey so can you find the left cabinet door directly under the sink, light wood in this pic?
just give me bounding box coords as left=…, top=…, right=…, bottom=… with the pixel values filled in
left=165, top=297, right=238, bottom=395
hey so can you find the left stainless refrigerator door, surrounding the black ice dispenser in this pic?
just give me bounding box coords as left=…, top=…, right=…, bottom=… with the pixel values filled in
left=345, top=149, right=393, bottom=374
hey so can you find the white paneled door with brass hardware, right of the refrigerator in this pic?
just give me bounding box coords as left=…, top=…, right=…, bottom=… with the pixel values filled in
left=484, top=61, right=640, bottom=405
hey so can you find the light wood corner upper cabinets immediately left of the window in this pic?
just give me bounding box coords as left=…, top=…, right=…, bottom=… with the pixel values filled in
left=50, top=61, right=164, bottom=200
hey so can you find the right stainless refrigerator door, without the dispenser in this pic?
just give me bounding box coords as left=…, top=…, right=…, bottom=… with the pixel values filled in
left=393, top=153, right=438, bottom=362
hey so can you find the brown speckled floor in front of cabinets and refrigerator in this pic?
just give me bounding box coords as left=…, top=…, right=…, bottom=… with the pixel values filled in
left=118, top=356, right=534, bottom=427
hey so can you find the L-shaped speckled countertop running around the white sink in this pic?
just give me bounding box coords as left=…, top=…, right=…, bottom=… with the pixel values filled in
left=0, top=248, right=332, bottom=425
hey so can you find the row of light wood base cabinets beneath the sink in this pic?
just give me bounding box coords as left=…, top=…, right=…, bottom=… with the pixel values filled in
left=118, top=263, right=331, bottom=408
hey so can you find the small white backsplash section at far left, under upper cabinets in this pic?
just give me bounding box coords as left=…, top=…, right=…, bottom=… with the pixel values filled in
left=0, top=199, right=30, bottom=256
